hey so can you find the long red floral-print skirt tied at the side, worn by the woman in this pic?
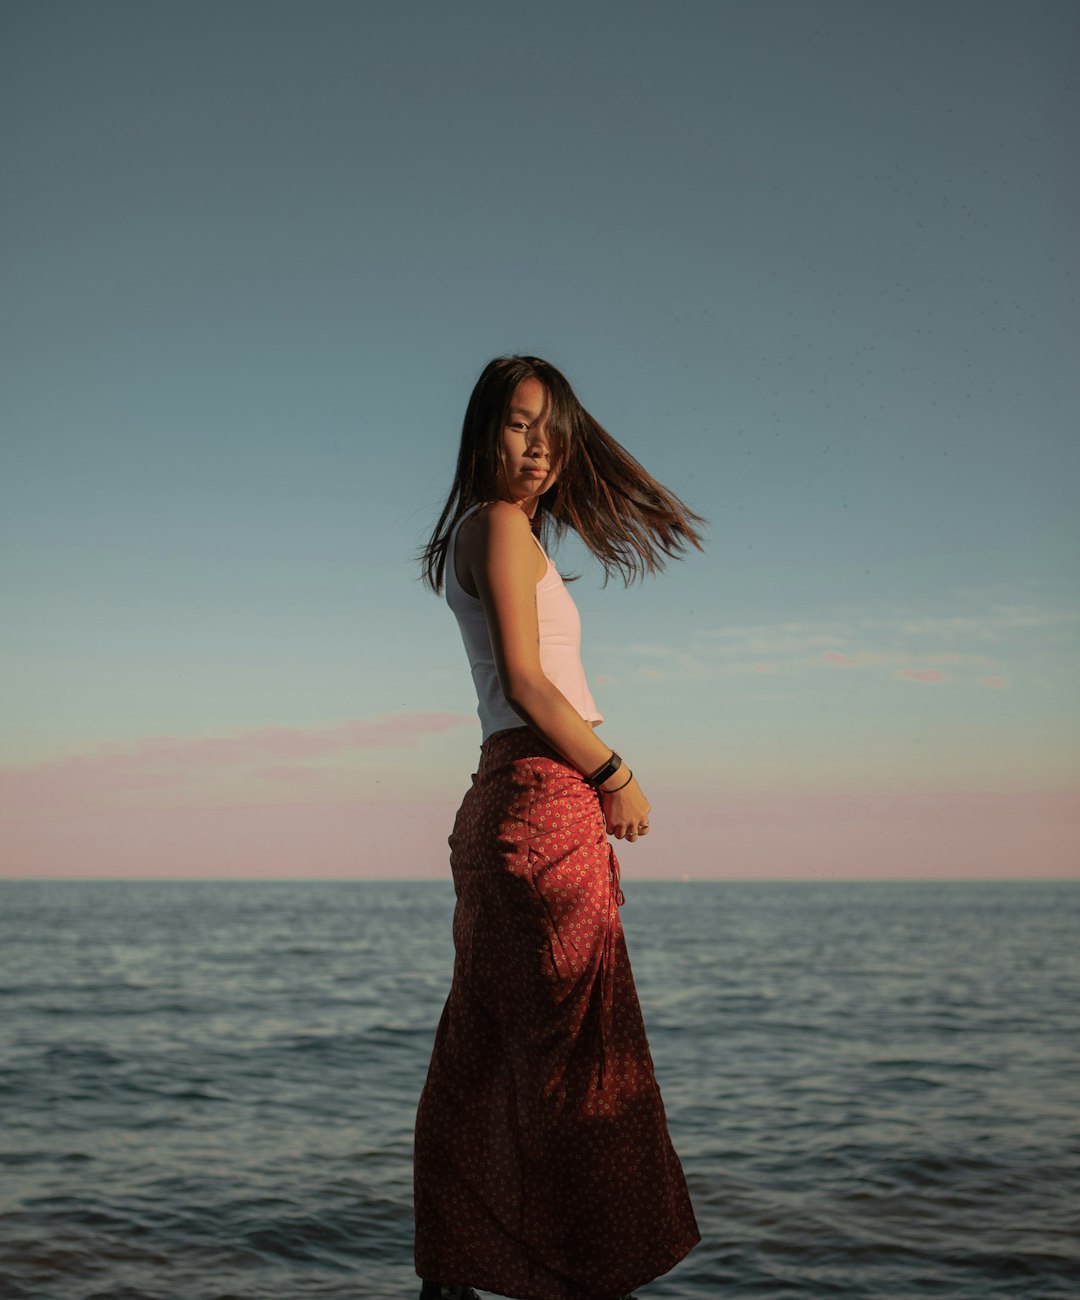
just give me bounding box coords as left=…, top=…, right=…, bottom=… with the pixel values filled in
left=413, top=727, right=701, bottom=1300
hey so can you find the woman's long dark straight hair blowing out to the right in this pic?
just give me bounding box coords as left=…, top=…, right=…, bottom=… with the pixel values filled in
left=420, top=356, right=706, bottom=592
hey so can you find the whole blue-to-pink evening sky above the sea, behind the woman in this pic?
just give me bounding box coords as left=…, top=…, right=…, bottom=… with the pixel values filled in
left=0, top=0, right=1080, bottom=879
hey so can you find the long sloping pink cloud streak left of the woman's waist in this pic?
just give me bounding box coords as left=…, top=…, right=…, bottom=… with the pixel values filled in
left=0, top=712, right=476, bottom=810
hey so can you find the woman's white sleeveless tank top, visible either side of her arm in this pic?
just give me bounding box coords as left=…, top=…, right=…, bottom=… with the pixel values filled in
left=444, top=506, right=604, bottom=741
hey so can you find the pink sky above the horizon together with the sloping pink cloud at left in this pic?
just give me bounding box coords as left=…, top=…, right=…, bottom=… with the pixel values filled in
left=0, top=712, right=1080, bottom=879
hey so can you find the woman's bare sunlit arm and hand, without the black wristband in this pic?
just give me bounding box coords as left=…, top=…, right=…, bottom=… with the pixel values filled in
left=465, top=502, right=649, bottom=839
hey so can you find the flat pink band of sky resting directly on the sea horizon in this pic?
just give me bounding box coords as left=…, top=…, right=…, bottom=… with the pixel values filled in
left=0, top=790, right=1080, bottom=879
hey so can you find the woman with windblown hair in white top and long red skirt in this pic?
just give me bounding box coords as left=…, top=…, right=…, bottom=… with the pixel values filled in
left=415, top=356, right=703, bottom=1300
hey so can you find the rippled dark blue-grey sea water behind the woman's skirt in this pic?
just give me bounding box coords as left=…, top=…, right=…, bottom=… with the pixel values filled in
left=0, top=872, right=1080, bottom=1300
